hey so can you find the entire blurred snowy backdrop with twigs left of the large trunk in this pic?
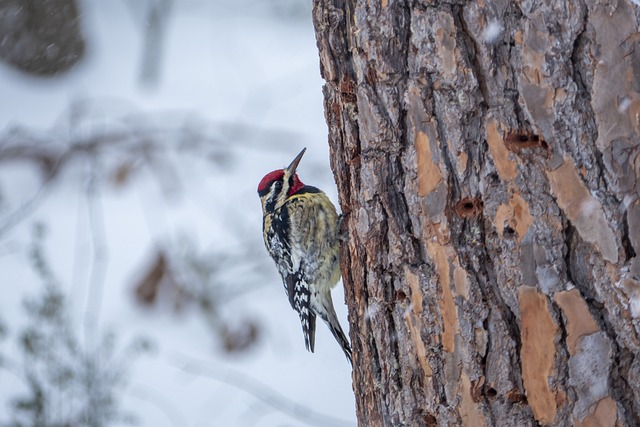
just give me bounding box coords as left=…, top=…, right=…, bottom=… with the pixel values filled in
left=0, top=0, right=356, bottom=427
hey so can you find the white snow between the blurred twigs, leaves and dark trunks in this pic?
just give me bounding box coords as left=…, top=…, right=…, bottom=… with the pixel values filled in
left=0, top=0, right=355, bottom=427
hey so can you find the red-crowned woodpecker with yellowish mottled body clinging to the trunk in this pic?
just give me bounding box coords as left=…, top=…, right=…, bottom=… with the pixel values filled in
left=258, top=148, right=353, bottom=364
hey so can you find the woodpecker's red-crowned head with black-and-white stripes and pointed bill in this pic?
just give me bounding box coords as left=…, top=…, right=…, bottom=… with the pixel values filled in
left=258, top=148, right=307, bottom=214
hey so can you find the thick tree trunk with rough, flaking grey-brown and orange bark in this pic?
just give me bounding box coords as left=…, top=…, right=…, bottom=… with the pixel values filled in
left=313, top=0, right=640, bottom=427
